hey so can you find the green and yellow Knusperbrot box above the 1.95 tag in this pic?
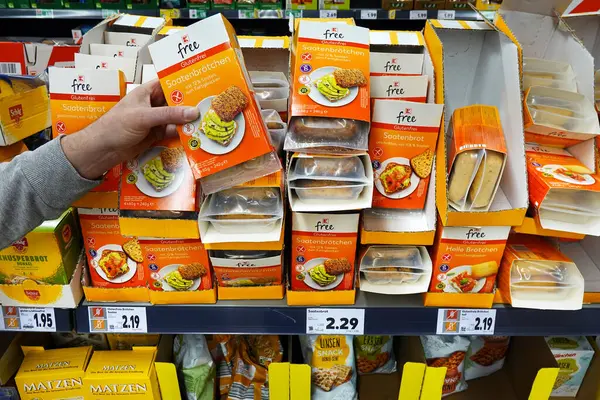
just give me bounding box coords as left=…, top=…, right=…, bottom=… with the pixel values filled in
left=0, top=210, right=81, bottom=285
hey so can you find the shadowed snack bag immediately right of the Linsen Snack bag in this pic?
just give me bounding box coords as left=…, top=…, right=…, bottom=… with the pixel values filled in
left=354, top=335, right=396, bottom=375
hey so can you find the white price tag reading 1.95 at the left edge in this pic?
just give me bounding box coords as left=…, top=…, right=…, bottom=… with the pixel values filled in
left=0, top=306, right=56, bottom=332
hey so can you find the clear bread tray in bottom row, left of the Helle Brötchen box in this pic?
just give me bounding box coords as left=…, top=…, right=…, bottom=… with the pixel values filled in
left=360, top=246, right=427, bottom=285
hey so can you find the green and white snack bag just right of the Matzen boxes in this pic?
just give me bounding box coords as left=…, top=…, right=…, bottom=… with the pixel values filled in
left=173, top=335, right=215, bottom=400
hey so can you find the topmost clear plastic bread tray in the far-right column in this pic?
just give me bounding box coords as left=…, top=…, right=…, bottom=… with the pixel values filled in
left=523, top=57, right=577, bottom=92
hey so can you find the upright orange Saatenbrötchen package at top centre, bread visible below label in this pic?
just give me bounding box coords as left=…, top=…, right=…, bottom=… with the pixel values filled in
left=284, top=20, right=370, bottom=153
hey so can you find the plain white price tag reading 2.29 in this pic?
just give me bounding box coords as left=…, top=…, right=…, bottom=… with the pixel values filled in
left=306, top=308, right=365, bottom=335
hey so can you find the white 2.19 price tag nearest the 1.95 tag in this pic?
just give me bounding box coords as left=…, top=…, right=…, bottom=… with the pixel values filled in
left=89, top=307, right=148, bottom=333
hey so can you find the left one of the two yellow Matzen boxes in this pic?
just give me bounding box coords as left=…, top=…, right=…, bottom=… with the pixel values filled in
left=15, top=346, right=92, bottom=400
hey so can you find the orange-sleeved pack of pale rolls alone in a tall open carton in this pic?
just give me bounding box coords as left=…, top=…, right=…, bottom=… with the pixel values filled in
left=448, top=104, right=506, bottom=211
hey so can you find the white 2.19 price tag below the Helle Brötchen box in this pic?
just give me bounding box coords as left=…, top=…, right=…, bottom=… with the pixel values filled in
left=436, top=308, right=496, bottom=335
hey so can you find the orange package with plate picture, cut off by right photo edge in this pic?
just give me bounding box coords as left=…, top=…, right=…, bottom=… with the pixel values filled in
left=525, top=144, right=600, bottom=236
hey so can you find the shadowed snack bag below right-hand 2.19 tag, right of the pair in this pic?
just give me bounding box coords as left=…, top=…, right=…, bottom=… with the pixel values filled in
left=465, top=336, right=510, bottom=381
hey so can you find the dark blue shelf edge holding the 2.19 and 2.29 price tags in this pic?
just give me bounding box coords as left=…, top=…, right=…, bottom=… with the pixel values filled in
left=76, top=292, right=600, bottom=336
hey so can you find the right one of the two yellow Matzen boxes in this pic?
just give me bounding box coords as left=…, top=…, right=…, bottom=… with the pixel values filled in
left=83, top=347, right=161, bottom=400
